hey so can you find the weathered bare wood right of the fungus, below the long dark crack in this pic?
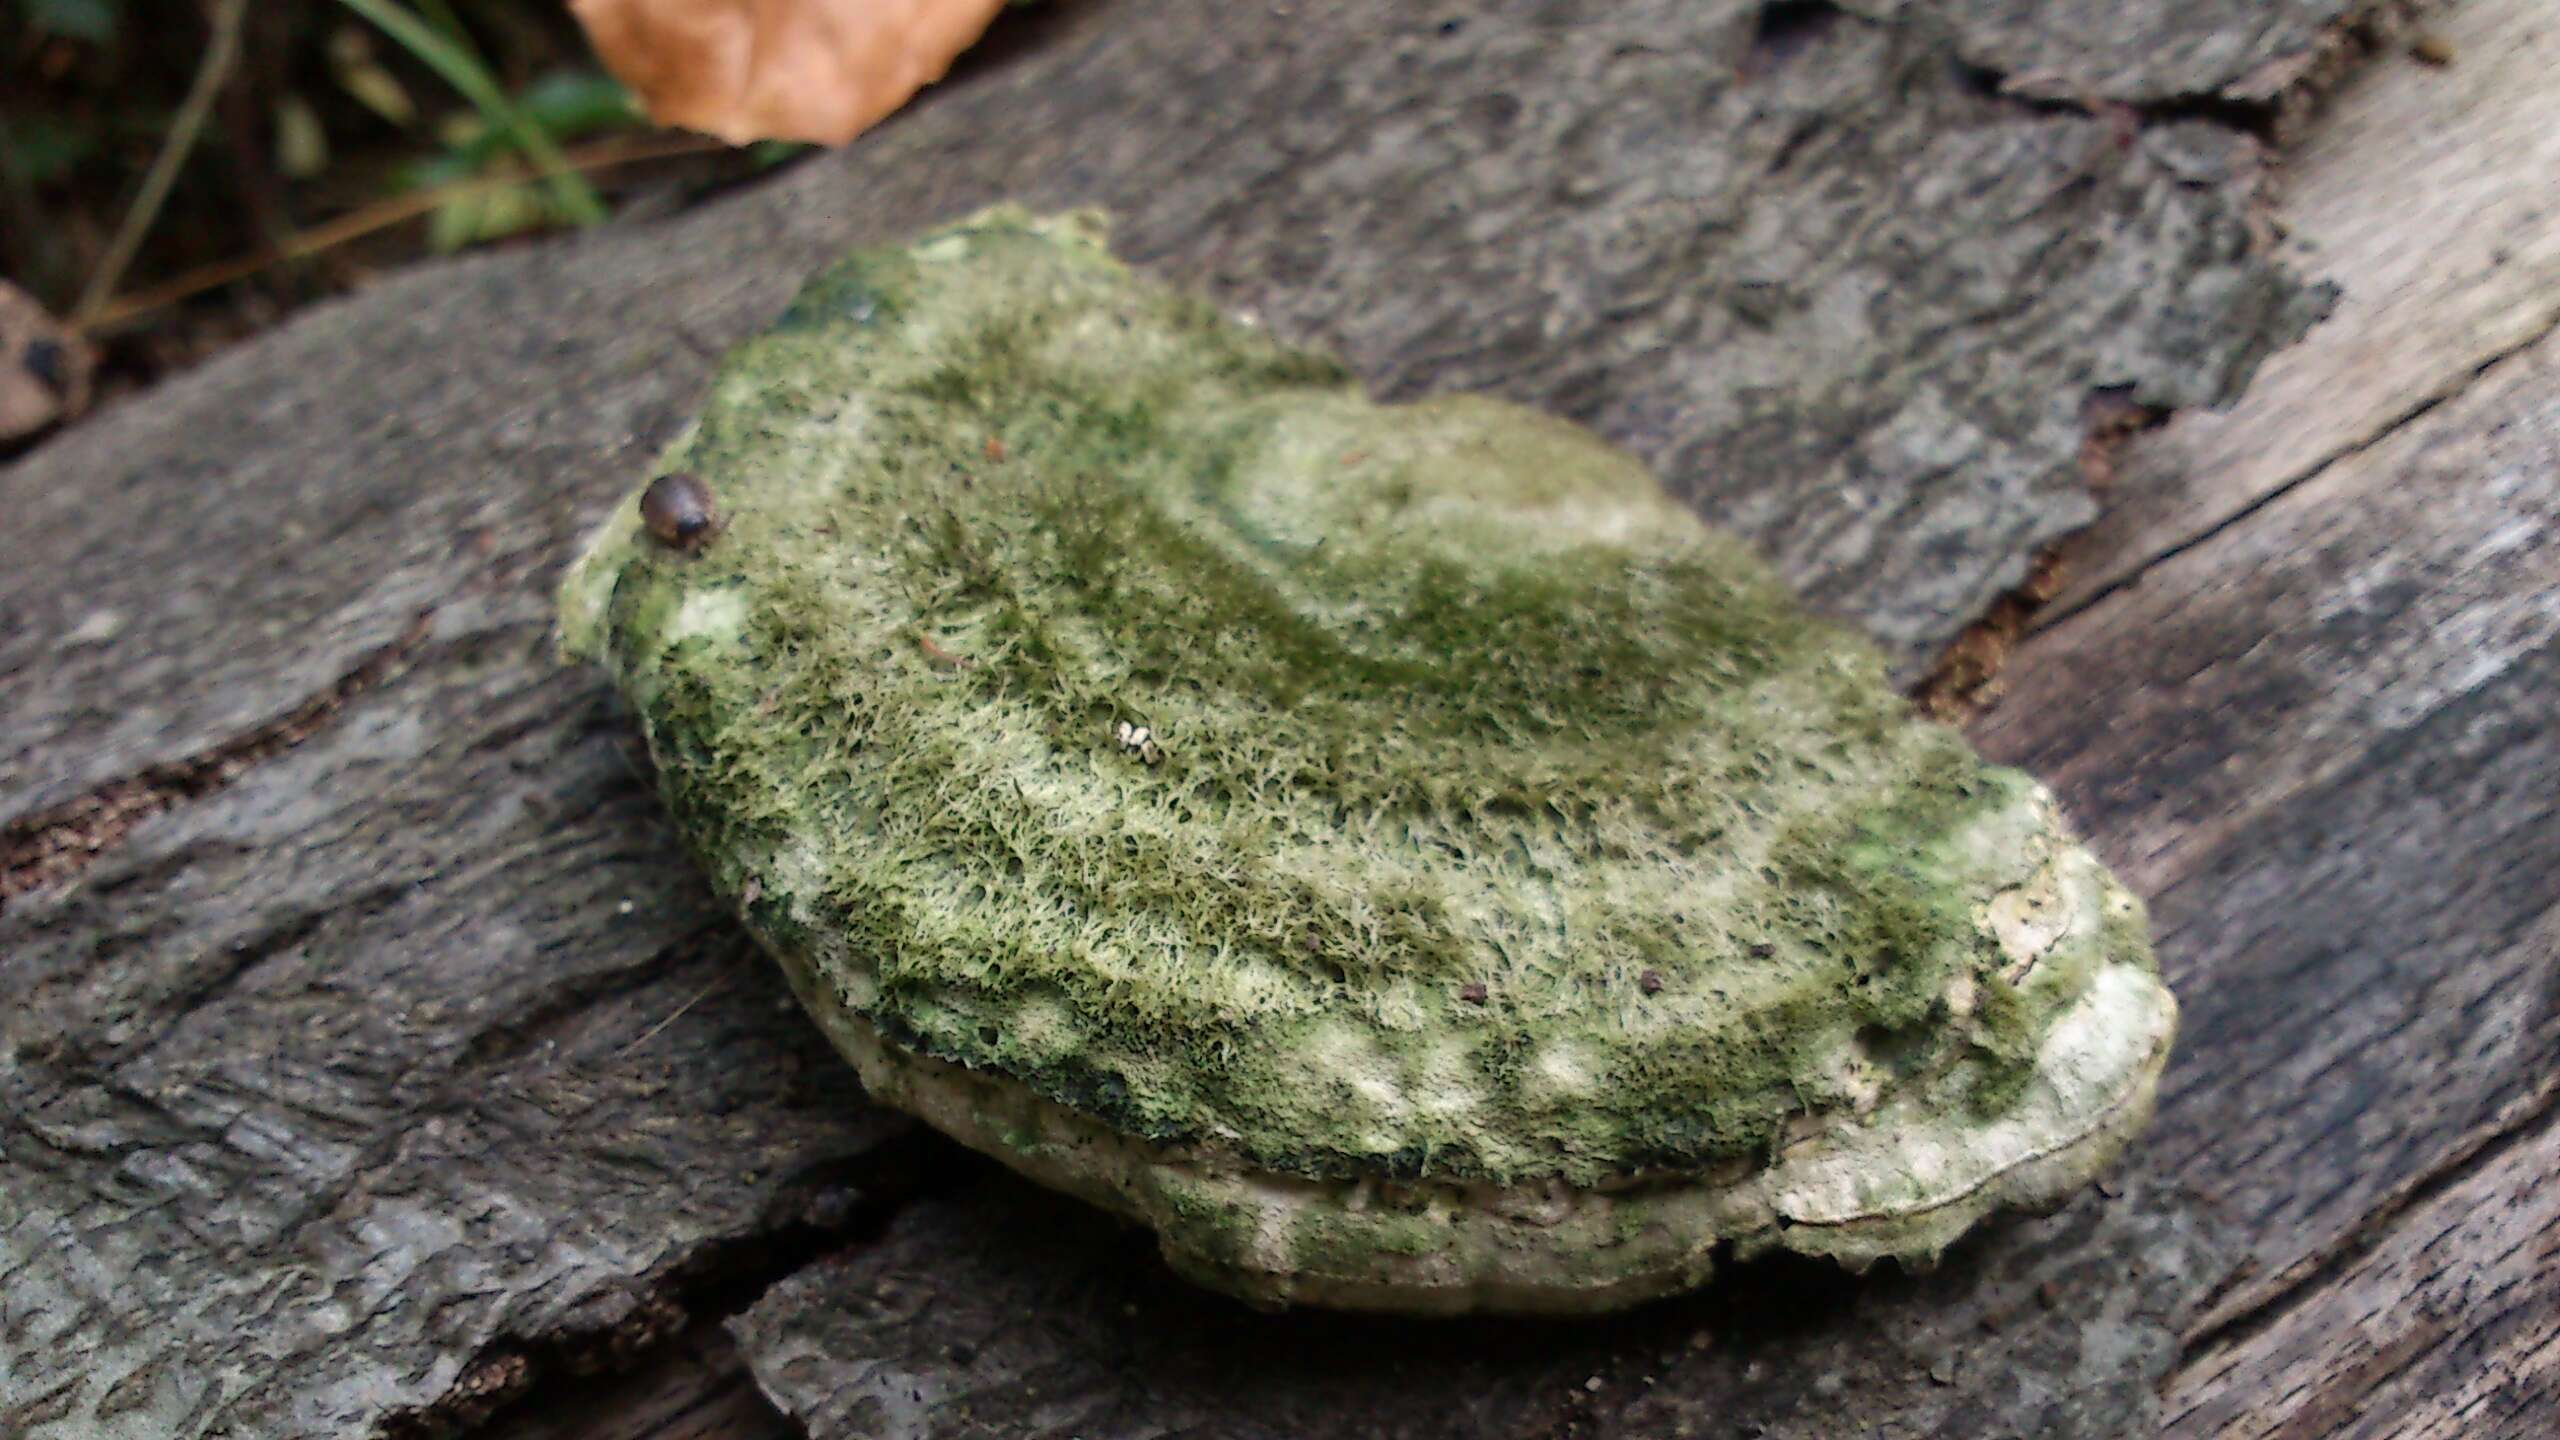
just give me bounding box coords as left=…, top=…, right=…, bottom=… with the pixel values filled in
left=1981, top=294, right=2560, bottom=1435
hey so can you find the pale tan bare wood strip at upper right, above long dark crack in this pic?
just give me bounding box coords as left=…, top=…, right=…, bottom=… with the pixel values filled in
left=2043, top=0, right=2560, bottom=609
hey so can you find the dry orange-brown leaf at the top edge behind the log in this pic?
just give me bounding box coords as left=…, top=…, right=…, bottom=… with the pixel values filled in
left=568, top=0, right=1004, bottom=146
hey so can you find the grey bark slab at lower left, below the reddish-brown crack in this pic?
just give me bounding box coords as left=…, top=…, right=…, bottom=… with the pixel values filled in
left=0, top=599, right=904, bottom=1440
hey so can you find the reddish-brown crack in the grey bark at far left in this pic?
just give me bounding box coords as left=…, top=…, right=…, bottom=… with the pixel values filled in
left=0, top=610, right=435, bottom=910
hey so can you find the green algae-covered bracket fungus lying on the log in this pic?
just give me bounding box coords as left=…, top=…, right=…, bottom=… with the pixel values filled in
left=563, top=210, right=2176, bottom=1312
